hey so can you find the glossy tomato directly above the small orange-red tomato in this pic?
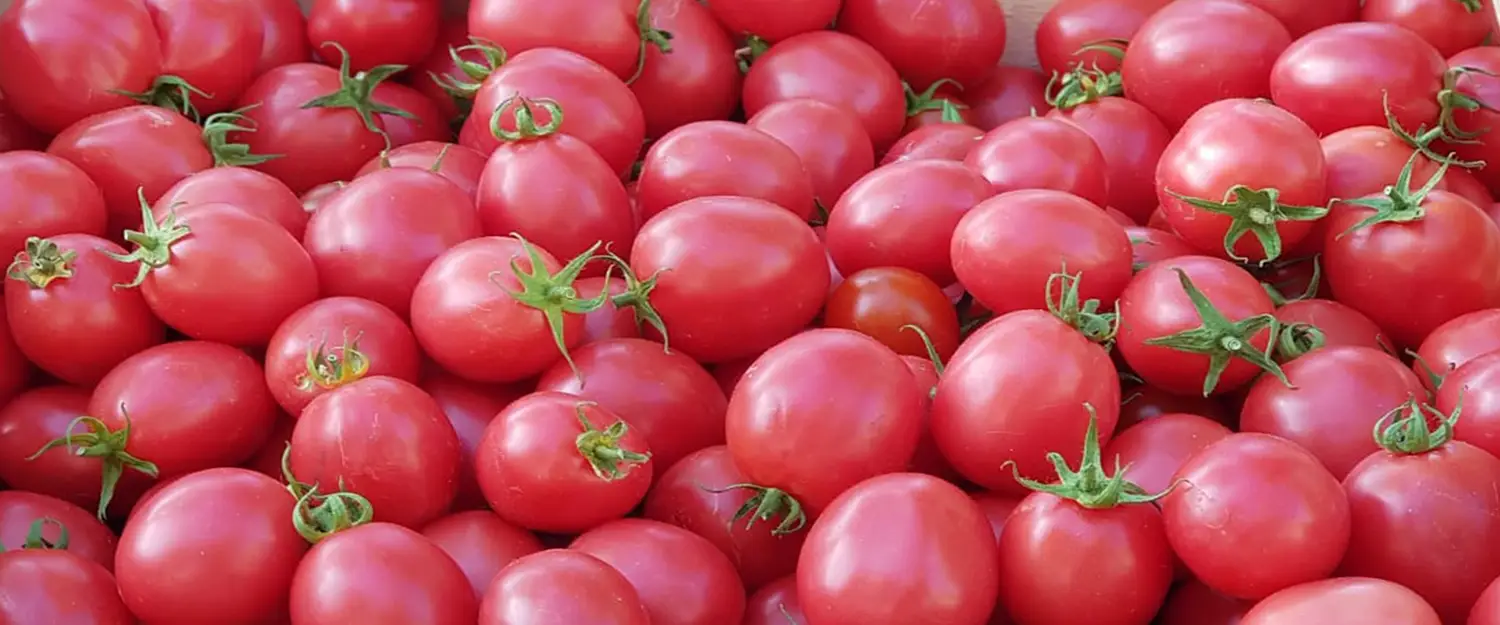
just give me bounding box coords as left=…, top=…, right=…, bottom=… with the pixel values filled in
left=828, top=160, right=995, bottom=286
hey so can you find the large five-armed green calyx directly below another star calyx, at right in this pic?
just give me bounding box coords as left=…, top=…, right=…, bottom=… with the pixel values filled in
left=1146, top=270, right=1296, bottom=397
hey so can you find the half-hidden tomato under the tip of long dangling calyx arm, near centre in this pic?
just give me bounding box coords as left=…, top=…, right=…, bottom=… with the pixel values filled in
left=537, top=339, right=729, bottom=468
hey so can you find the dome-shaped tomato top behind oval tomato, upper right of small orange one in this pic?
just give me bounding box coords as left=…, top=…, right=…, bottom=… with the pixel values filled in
left=963, top=117, right=1110, bottom=207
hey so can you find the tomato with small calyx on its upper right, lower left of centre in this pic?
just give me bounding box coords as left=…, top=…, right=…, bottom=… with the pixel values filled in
left=474, top=391, right=654, bottom=534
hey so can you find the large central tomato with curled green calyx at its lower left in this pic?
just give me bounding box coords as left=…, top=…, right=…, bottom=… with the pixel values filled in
left=725, top=328, right=927, bottom=524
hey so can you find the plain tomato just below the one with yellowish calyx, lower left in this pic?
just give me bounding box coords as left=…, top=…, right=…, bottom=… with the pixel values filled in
left=291, top=376, right=461, bottom=528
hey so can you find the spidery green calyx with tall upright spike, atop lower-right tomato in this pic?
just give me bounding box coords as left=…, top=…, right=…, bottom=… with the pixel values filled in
left=1005, top=402, right=1172, bottom=510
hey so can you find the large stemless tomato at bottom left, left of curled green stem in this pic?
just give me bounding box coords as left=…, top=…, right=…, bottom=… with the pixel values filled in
left=116, top=468, right=308, bottom=625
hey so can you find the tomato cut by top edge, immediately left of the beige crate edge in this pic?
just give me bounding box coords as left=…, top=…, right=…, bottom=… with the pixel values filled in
left=839, top=0, right=1005, bottom=90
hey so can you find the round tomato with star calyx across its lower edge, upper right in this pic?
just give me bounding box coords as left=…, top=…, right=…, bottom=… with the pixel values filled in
left=1157, top=99, right=1329, bottom=262
